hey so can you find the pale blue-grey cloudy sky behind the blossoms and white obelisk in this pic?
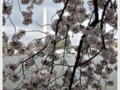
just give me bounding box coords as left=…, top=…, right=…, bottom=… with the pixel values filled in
left=3, top=0, right=117, bottom=45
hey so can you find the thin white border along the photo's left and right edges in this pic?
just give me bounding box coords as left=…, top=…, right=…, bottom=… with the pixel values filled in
left=0, top=0, right=120, bottom=90
